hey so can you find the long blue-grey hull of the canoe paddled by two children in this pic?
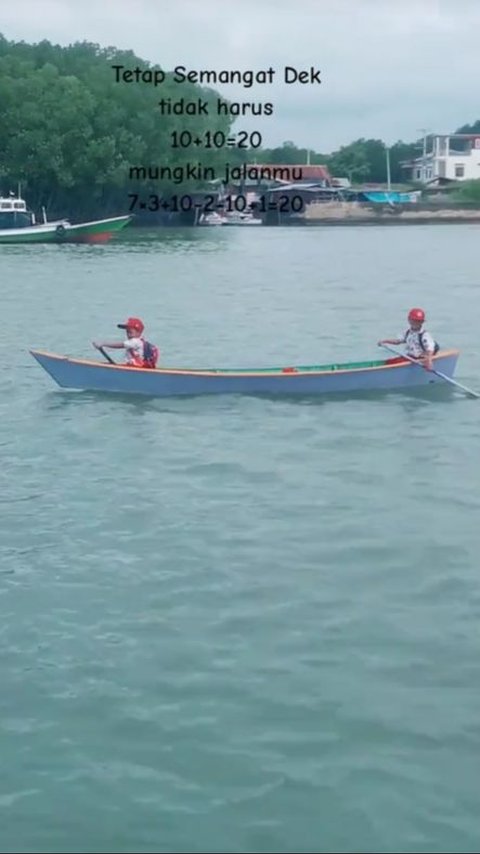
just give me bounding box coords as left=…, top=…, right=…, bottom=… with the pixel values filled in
left=31, top=350, right=459, bottom=397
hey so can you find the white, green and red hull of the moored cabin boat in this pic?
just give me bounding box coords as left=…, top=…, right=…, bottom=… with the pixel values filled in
left=0, top=215, right=132, bottom=244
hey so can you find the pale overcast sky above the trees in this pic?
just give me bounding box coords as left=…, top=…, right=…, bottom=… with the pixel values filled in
left=0, top=0, right=480, bottom=153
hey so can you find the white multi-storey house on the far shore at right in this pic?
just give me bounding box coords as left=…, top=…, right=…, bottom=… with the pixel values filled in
left=402, top=133, right=480, bottom=184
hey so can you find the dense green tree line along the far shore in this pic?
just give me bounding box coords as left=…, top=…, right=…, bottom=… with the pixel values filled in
left=0, top=34, right=480, bottom=218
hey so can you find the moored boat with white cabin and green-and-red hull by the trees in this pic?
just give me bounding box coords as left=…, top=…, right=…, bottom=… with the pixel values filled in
left=0, top=195, right=132, bottom=244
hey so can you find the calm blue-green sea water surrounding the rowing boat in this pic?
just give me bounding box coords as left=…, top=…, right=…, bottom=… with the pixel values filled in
left=0, top=226, right=480, bottom=854
